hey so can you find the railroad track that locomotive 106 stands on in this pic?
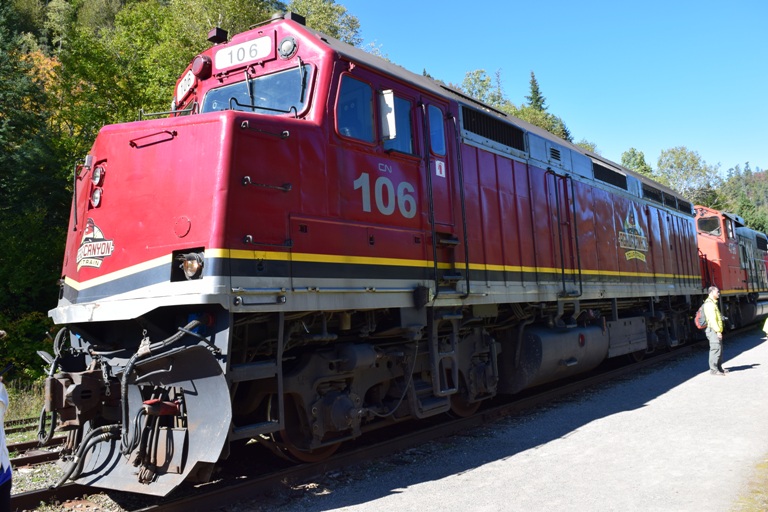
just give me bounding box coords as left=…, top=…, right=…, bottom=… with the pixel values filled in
left=11, top=338, right=708, bottom=512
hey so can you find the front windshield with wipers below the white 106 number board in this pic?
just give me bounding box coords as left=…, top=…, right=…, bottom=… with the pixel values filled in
left=202, top=65, right=312, bottom=115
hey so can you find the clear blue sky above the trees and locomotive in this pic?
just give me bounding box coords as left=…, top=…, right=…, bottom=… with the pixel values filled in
left=336, top=0, right=768, bottom=174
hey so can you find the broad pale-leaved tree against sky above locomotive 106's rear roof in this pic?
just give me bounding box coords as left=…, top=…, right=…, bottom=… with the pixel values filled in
left=657, top=146, right=722, bottom=203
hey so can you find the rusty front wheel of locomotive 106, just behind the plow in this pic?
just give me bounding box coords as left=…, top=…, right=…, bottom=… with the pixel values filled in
left=270, top=395, right=341, bottom=462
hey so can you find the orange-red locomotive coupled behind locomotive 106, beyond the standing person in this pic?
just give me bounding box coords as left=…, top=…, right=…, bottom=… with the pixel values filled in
left=695, top=206, right=768, bottom=328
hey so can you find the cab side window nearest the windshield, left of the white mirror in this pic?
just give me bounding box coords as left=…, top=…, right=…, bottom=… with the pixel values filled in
left=336, top=75, right=373, bottom=142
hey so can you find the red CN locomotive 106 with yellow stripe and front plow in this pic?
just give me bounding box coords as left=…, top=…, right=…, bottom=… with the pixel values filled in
left=42, top=15, right=765, bottom=495
